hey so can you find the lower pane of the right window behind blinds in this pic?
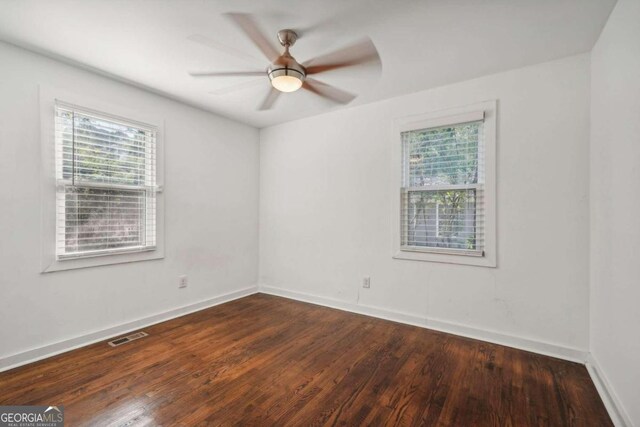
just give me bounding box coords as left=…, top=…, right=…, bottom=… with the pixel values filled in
left=402, top=189, right=482, bottom=250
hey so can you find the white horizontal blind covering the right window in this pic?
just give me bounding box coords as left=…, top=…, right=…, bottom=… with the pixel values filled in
left=400, top=117, right=484, bottom=256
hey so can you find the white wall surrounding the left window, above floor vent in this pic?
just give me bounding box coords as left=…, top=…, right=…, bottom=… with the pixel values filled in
left=0, top=43, right=259, bottom=359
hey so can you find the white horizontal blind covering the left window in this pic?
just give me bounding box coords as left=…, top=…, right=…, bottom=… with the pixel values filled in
left=55, top=102, right=157, bottom=259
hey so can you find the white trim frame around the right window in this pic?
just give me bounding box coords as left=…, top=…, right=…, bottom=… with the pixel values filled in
left=391, top=100, right=497, bottom=267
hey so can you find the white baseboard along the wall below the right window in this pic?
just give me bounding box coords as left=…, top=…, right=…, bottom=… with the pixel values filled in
left=260, top=285, right=588, bottom=364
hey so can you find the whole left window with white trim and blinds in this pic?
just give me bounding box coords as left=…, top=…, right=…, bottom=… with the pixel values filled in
left=39, top=85, right=165, bottom=273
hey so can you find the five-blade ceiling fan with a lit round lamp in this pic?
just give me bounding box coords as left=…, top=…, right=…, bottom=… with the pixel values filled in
left=189, top=13, right=380, bottom=110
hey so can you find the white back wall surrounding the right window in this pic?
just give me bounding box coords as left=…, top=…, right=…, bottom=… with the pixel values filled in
left=260, top=55, right=589, bottom=351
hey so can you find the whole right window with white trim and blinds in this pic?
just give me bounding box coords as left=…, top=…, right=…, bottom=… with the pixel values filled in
left=394, top=102, right=495, bottom=266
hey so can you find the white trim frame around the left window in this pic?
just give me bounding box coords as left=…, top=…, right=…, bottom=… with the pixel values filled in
left=39, top=85, right=164, bottom=273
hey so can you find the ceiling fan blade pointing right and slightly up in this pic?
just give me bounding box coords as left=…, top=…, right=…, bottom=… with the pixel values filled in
left=302, top=38, right=381, bottom=74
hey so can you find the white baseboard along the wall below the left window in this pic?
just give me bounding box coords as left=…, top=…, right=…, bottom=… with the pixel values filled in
left=0, top=286, right=258, bottom=372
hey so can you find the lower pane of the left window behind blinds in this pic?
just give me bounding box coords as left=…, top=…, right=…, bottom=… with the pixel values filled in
left=58, top=187, right=146, bottom=255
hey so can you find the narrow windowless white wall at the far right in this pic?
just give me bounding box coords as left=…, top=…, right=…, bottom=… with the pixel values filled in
left=590, top=0, right=640, bottom=426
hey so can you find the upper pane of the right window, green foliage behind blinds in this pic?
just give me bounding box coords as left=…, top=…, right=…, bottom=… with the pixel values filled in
left=402, top=122, right=482, bottom=187
